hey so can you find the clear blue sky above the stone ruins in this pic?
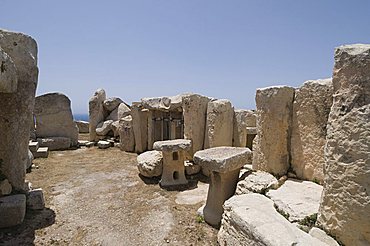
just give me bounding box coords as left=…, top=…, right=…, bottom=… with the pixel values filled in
left=0, top=0, right=370, bottom=113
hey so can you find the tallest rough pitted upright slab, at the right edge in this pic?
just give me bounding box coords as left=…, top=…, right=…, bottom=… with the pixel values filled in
left=318, top=44, right=370, bottom=245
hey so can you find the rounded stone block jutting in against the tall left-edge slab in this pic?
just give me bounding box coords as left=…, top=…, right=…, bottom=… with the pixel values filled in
left=0, top=48, right=18, bottom=93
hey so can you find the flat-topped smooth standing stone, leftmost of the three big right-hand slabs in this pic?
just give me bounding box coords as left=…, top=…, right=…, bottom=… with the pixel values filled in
left=253, top=86, right=294, bottom=176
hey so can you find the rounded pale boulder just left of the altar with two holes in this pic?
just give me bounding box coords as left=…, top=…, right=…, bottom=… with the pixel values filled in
left=137, top=150, right=163, bottom=178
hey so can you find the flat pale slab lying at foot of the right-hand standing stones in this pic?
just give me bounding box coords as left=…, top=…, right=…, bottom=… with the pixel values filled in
left=266, top=179, right=323, bottom=222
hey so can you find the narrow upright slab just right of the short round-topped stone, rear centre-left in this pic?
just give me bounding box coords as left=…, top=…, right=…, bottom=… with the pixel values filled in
left=131, top=103, right=149, bottom=153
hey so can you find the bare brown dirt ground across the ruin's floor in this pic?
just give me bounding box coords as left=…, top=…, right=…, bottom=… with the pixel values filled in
left=0, top=135, right=217, bottom=245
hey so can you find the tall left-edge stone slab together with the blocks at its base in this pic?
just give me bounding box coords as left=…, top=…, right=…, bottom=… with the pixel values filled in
left=0, top=30, right=44, bottom=228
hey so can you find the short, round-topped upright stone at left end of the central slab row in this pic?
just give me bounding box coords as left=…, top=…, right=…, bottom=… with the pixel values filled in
left=119, top=115, right=135, bottom=152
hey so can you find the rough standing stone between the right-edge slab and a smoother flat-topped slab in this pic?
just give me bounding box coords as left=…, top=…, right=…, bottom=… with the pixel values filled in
left=291, top=79, right=333, bottom=182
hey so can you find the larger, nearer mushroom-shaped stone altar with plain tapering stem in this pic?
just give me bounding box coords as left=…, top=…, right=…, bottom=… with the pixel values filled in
left=193, top=147, right=252, bottom=227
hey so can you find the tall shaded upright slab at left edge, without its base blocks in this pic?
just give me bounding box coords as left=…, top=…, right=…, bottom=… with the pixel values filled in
left=0, top=30, right=38, bottom=189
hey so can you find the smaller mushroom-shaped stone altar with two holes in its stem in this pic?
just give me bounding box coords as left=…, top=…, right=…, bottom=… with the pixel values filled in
left=153, top=139, right=191, bottom=187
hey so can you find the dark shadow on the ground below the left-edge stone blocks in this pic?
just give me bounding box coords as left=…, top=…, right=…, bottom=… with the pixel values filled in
left=0, top=208, right=55, bottom=246
